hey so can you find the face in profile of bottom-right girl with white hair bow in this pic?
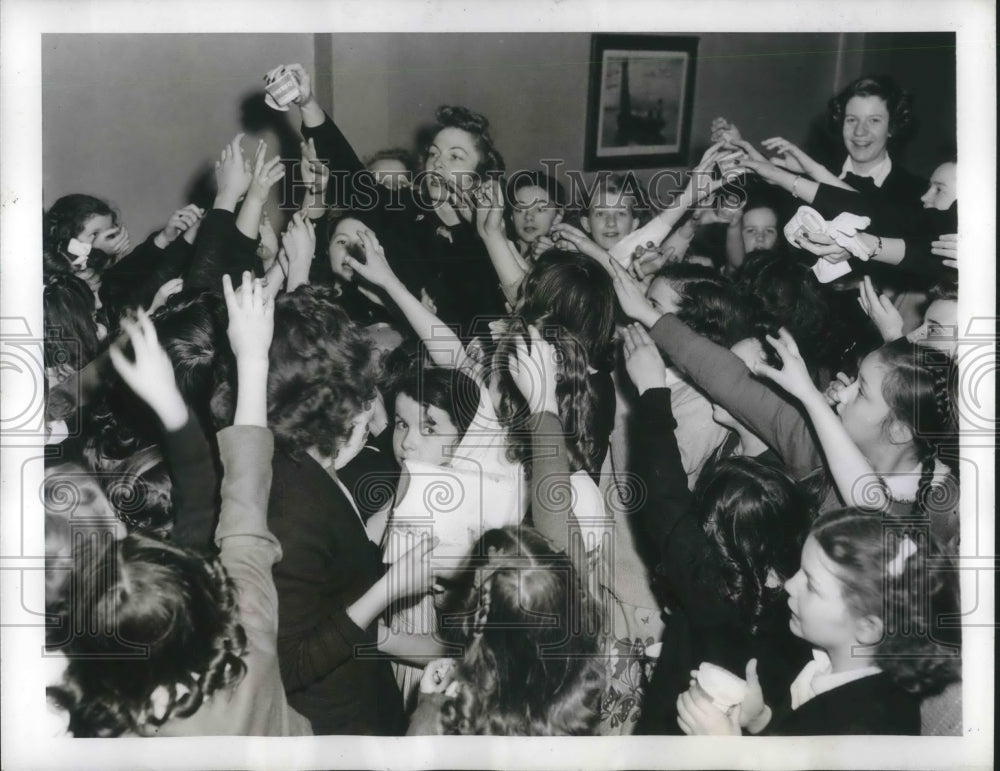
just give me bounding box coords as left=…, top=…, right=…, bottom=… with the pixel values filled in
left=785, top=536, right=859, bottom=651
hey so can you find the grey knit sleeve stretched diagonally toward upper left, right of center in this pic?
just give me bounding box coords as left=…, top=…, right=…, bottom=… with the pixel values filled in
left=650, top=313, right=822, bottom=479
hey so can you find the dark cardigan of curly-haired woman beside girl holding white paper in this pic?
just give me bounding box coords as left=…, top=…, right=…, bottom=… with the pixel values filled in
left=268, top=453, right=406, bottom=735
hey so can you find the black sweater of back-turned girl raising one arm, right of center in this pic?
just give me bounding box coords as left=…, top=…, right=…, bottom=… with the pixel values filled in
left=631, top=388, right=811, bottom=734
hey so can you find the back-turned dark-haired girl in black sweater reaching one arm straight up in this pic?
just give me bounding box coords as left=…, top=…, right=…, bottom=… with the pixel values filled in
left=625, top=325, right=811, bottom=734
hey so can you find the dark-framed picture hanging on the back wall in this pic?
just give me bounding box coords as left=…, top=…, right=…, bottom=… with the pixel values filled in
left=584, top=34, right=698, bottom=171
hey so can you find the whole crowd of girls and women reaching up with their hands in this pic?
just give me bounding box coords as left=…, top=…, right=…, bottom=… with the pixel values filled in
left=44, top=65, right=961, bottom=736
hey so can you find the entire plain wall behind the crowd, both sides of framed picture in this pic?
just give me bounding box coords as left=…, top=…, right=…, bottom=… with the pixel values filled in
left=42, top=33, right=955, bottom=239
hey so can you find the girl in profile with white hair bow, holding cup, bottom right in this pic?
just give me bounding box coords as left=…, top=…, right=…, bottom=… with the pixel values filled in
left=677, top=508, right=959, bottom=736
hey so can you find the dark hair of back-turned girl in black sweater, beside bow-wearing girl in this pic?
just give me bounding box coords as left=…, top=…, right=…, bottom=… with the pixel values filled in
left=692, top=457, right=813, bottom=634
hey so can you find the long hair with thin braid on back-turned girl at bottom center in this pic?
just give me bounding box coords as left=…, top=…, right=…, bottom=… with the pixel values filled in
left=440, top=527, right=606, bottom=736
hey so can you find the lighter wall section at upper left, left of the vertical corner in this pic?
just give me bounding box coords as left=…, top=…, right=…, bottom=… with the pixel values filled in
left=42, top=34, right=314, bottom=243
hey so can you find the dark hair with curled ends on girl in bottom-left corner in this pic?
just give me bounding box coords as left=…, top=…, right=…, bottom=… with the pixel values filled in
left=47, top=534, right=247, bottom=737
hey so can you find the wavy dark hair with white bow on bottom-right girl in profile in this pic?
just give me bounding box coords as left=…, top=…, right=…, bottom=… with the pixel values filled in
left=810, top=508, right=960, bottom=695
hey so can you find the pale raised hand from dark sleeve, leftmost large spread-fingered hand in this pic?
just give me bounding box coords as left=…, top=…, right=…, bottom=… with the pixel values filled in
left=108, top=308, right=187, bottom=431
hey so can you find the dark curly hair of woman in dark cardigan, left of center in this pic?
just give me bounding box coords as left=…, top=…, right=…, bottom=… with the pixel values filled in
left=212, top=285, right=378, bottom=458
